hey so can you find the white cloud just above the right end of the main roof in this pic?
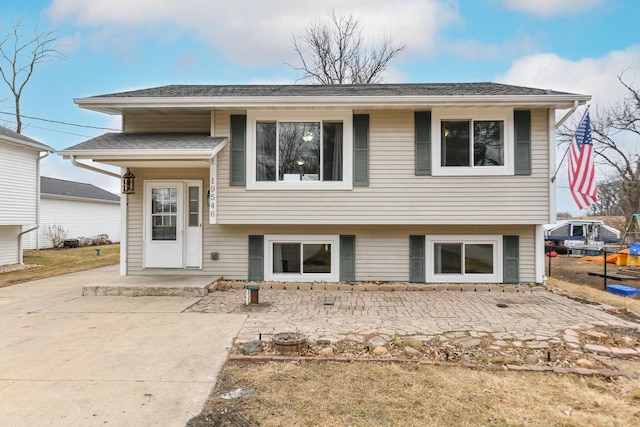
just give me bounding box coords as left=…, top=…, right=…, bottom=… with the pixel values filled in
left=496, top=45, right=640, bottom=106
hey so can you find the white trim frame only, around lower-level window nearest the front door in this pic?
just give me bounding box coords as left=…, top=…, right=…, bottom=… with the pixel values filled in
left=264, top=234, right=340, bottom=282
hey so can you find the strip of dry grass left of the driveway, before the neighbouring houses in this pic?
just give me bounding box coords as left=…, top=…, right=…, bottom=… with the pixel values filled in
left=0, top=244, right=120, bottom=288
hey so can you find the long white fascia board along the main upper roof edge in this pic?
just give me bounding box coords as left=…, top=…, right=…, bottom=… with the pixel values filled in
left=74, top=95, right=591, bottom=114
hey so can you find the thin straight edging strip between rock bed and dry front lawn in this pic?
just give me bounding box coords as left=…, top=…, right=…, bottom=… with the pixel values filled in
left=228, top=354, right=636, bottom=378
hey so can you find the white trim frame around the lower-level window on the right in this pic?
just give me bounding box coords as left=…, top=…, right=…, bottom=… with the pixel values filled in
left=425, top=235, right=503, bottom=283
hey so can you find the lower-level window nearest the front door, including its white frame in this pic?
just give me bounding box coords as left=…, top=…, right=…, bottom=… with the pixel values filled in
left=264, top=235, right=339, bottom=281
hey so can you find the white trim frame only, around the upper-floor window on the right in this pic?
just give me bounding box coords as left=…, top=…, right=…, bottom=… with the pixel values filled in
left=431, top=108, right=515, bottom=176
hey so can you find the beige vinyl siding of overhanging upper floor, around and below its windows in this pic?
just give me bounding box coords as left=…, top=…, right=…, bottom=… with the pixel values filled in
left=215, top=109, right=550, bottom=225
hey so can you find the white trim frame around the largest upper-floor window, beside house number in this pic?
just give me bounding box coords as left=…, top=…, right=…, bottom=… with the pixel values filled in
left=246, top=110, right=353, bottom=190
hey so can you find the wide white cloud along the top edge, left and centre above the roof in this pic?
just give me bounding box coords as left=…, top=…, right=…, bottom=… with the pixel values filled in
left=48, top=0, right=459, bottom=64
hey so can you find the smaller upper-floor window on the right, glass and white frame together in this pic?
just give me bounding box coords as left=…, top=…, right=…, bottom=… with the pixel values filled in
left=431, top=108, right=515, bottom=176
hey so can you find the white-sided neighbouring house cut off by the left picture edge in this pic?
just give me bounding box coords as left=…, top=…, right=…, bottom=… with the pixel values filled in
left=0, top=126, right=54, bottom=265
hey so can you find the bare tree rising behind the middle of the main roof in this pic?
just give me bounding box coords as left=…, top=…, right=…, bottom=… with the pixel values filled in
left=291, top=10, right=406, bottom=85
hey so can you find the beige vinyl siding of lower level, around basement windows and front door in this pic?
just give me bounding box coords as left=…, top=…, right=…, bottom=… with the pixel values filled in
left=127, top=196, right=535, bottom=282
